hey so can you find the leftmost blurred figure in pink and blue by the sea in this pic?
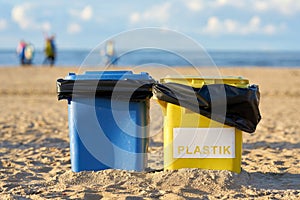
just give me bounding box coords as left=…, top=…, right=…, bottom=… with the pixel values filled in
left=17, top=40, right=34, bottom=66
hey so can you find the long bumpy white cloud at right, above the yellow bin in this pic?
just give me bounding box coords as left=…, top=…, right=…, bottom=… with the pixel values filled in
left=203, top=16, right=285, bottom=35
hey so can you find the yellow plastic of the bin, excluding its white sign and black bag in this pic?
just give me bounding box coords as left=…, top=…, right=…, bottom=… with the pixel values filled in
left=158, top=76, right=249, bottom=173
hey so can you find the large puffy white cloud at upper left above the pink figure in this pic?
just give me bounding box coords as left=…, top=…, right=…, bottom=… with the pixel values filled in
left=11, top=3, right=51, bottom=31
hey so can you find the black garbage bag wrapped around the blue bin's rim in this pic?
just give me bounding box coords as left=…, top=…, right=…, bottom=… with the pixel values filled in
left=56, top=79, right=154, bottom=101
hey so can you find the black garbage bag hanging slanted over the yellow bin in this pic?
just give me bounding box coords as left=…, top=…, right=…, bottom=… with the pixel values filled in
left=153, top=83, right=261, bottom=133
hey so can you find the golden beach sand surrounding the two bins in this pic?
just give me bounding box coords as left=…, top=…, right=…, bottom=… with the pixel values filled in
left=0, top=66, right=300, bottom=199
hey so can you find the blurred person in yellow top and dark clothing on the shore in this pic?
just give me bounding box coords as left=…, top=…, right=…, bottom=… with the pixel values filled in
left=43, top=35, right=56, bottom=66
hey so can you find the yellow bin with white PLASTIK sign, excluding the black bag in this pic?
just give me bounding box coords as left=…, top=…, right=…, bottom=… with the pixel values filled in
left=158, top=76, right=249, bottom=173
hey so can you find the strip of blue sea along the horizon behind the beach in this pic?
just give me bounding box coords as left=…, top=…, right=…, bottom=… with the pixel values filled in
left=0, top=50, right=300, bottom=67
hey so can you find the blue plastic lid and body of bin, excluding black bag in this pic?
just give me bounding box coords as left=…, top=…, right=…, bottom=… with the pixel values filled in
left=66, top=71, right=149, bottom=172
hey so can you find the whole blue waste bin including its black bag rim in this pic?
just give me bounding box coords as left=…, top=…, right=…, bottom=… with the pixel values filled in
left=57, top=71, right=154, bottom=172
